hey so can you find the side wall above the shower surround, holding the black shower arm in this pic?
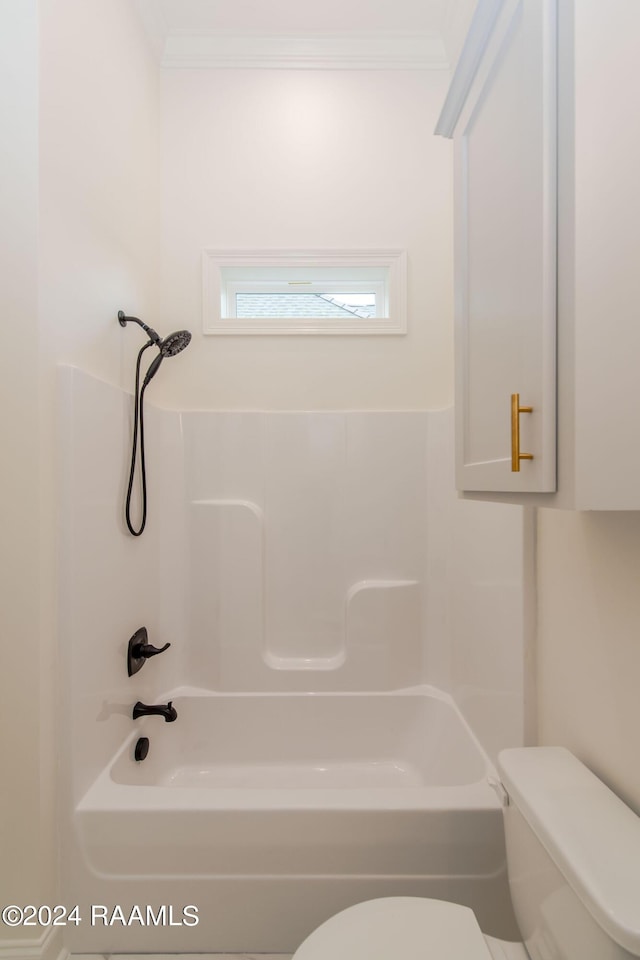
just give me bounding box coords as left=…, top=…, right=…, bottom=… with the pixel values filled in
left=40, top=0, right=161, bottom=386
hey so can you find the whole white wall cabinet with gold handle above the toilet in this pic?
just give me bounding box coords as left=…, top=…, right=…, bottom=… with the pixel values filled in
left=437, top=0, right=640, bottom=510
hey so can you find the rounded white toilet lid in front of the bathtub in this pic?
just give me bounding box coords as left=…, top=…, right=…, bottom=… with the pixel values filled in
left=292, top=897, right=491, bottom=960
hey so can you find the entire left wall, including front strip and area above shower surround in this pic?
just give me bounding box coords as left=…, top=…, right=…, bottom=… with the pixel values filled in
left=0, top=0, right=159, bottom=936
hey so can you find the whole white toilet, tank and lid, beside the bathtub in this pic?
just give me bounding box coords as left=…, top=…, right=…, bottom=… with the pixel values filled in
left=293, top=747, right=640, bottom=960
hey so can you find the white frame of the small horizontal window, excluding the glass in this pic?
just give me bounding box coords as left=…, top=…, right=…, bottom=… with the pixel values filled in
left=202, top=248, right=407, bottom=336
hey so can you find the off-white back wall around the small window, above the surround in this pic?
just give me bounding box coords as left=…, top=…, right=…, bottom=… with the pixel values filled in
left=157, top=70, right=452, bottom=410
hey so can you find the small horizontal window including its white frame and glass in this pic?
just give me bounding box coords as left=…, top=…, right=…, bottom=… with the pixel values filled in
left=203, top=250, right=406, bottom=335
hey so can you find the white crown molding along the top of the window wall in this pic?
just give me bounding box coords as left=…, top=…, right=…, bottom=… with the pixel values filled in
left=160, top=31, right=448, bottom=70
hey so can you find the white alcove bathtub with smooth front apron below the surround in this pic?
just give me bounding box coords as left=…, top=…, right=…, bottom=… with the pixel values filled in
left=65, top=687, right=515, bottom=953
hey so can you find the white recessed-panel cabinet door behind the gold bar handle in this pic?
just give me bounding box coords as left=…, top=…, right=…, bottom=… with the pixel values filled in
left=454, top=0, right=556, bottom=492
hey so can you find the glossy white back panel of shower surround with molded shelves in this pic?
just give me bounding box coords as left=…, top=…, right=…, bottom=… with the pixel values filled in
left=183, top=404, right=426, bottom=691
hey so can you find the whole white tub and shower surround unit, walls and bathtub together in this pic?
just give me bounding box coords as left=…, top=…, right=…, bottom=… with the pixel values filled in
left=60, top=368, right=523, bottom=952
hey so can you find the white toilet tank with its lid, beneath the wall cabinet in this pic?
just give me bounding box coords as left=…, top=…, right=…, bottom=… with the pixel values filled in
left=499, top=747, right=640, bottom=960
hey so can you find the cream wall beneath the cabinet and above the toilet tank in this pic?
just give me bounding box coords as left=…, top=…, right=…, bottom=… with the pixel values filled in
left=537, top=510, right=640, bottom=813
